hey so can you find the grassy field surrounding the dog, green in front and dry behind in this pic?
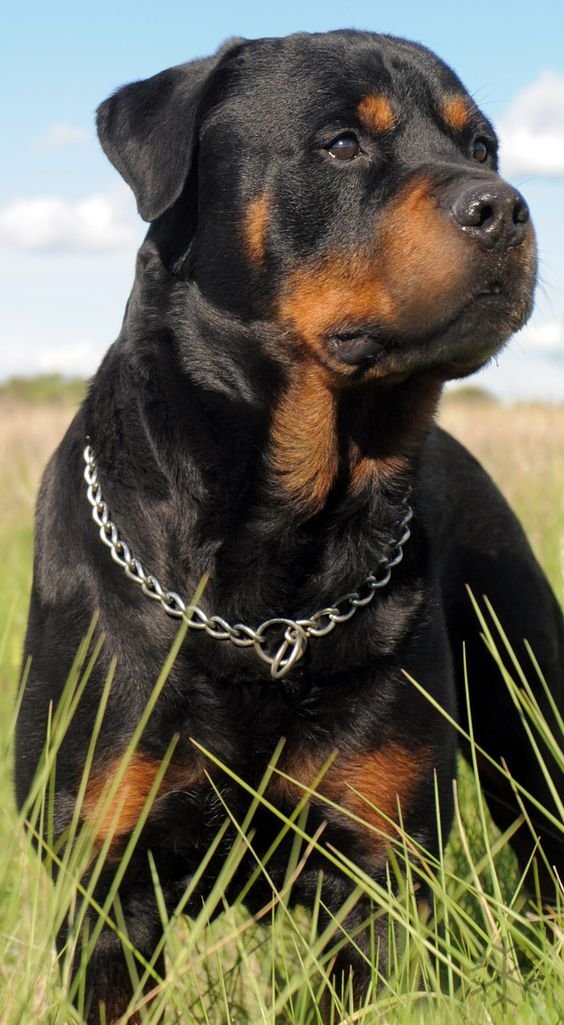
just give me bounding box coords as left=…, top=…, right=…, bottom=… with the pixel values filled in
left=0, top=385, right=564, bottom=1025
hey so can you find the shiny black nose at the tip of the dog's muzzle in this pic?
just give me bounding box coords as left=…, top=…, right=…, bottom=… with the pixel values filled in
left=450, top=181, right=530, bottom=249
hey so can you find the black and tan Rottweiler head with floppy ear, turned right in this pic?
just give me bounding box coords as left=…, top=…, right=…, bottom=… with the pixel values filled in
left=98, top=31, right=536, bottom=384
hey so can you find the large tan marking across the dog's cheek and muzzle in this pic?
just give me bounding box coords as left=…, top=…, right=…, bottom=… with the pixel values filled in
left=277, top=177, right=477, bottom=364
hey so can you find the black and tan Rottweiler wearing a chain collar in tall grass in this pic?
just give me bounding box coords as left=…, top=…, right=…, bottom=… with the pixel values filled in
left=16, top=30, right=564, bottom=1025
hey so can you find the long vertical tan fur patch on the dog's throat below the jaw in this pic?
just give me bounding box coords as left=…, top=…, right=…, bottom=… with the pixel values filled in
left=271, top=363, right=338, bottom=513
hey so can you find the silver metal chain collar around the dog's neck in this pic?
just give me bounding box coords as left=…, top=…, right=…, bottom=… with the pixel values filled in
left=84, top=445, right=413, bottom=680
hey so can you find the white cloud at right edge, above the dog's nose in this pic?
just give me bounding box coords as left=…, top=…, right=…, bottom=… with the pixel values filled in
left=498, top=71, right=564, bottom=177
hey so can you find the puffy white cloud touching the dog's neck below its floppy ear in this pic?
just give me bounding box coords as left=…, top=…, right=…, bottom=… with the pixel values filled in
left=0, top=187, right=139, bottom=252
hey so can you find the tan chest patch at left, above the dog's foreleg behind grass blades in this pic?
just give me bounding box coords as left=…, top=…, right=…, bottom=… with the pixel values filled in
left=82, top=752, right=202, bottom=845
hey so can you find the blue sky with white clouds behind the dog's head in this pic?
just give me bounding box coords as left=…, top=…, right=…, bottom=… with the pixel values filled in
left=0, top=0, right=564, bottom=401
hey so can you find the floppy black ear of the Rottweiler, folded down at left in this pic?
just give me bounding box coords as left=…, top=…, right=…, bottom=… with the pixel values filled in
left=96, top=40, right=243, bottom=220
